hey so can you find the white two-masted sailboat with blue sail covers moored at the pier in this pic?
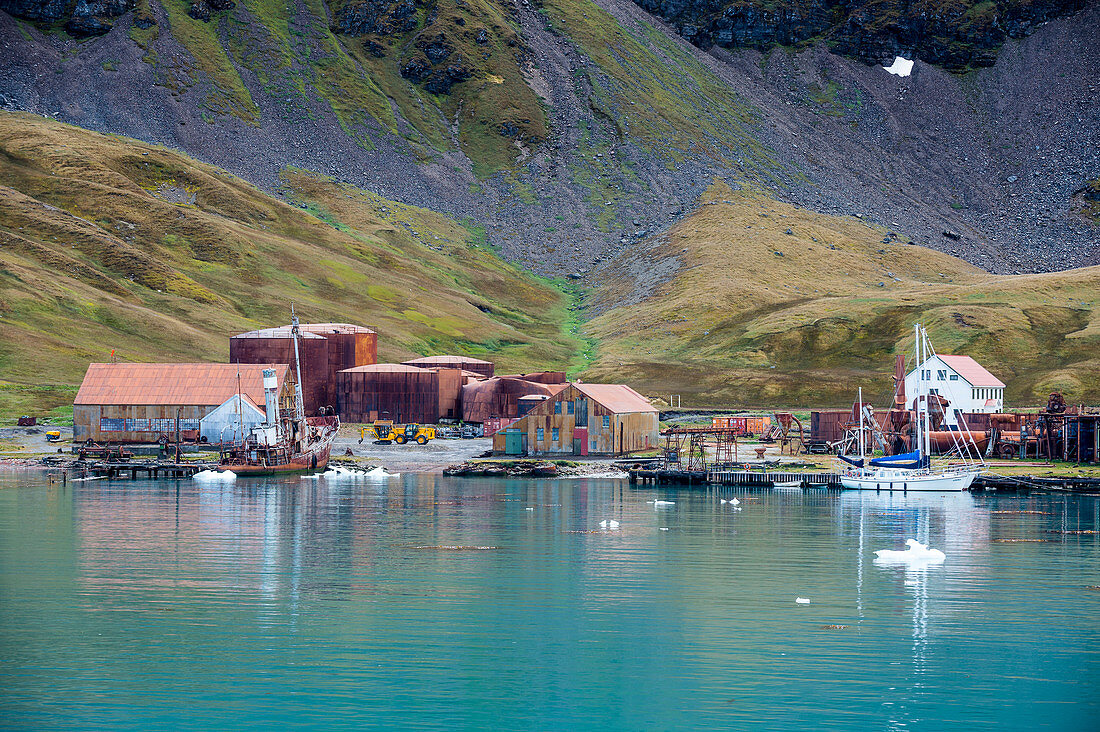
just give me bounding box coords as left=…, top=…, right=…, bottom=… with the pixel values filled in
left=837, top=324, right=981, bottom=492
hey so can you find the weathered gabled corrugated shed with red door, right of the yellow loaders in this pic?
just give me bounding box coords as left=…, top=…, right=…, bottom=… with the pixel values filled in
left=493, top=383, right=659, bottom=455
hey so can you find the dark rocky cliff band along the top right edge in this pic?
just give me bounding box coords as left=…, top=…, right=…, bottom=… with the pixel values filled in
left=636, top=0, right=1086, bottom=69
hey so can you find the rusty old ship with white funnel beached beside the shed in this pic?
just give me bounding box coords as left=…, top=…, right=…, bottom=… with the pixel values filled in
left=218, top=307, right=340, bottom=476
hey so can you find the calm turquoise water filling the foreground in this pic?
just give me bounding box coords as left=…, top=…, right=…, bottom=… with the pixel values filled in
left=0, top=473, right=1100, bottom=730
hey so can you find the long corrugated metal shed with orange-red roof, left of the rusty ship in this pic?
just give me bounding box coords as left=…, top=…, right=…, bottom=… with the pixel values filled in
left=73, top=363, right=293, bottom=443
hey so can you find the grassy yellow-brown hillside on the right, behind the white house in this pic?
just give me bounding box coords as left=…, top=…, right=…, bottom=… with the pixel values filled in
left=586, top=179, right=1100, bottom=406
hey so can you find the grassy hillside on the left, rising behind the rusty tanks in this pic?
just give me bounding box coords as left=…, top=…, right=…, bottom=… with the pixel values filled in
left=0, top=112, right=578, bottom=414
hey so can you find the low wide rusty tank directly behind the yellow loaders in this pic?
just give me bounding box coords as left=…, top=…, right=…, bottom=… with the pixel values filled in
left=337, top=363, right=439, bottom=425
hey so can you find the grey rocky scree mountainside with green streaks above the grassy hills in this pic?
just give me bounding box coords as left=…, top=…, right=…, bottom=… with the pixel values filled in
left=0, top=0, right=1100, bottom=278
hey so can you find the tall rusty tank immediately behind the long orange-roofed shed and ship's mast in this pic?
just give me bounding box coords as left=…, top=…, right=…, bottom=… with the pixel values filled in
left=229, top=326, right=332, bottom=415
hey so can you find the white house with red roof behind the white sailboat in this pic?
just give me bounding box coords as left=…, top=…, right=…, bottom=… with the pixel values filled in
left=905, top=354, right=1004, bottom=425
